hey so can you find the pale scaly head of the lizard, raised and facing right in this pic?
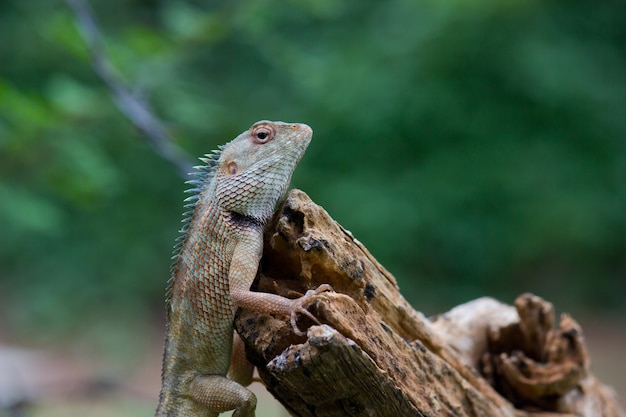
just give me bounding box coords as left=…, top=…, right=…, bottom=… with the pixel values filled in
left=215, top=121, right=313, bottom=222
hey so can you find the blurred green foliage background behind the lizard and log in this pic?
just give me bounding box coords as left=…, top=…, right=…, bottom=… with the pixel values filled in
left=0, top=0, right=626, bottom=417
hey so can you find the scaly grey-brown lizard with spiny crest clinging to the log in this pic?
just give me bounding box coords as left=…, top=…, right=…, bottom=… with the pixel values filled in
left=155, top=121, right=331, bottom=417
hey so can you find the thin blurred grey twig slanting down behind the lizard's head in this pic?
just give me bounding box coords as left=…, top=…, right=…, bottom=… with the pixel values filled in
left=66, top=0, right=193, bottom=178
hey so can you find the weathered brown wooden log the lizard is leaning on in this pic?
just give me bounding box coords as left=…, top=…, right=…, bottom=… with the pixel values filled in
left=235, top=190, right=624, bottom=417
